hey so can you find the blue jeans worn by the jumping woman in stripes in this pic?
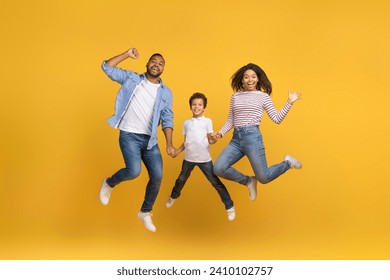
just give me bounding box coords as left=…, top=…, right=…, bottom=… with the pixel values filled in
left=214, top=125, right=290, bottom=185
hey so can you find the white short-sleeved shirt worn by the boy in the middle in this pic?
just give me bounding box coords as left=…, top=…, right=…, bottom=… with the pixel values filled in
left=183, top=116, right=213, bottom=163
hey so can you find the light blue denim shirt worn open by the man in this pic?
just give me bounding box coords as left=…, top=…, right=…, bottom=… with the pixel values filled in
left=102, top=61, right=173, bottom=149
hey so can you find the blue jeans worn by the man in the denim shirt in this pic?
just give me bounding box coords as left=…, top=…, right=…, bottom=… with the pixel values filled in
left=107, top=131, right=163, bottom=212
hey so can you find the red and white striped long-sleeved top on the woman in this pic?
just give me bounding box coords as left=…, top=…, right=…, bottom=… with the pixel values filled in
left=219, top=91, right=292, bottom=135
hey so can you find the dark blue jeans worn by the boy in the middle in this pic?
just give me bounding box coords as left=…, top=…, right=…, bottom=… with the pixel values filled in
left=171, top=160, right=233, bottom=210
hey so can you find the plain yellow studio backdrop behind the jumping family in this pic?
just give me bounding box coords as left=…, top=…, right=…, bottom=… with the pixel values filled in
left=0, top=0, right=390, bottom=259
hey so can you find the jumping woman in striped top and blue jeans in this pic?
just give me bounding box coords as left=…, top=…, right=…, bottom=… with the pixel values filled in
left=214, top=63, right=302, bottom=200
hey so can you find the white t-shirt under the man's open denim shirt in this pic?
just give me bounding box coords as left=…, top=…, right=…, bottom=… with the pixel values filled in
left=119, top=78, right=160, bottom=135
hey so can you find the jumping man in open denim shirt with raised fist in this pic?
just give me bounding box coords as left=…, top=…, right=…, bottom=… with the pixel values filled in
left=99, top=48, right=176, bottom=232
